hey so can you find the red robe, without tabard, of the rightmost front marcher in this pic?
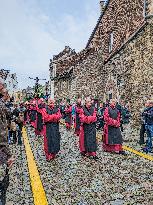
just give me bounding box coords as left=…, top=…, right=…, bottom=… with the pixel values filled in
left=103, top=107, right=122, bottom=152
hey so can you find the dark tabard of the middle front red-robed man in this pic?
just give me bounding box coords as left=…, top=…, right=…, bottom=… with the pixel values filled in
left=83, top=106, right=97, bottom=152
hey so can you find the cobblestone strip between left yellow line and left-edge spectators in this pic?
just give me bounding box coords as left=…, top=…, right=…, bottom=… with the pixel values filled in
left=6, top=141, right=34, bottom=205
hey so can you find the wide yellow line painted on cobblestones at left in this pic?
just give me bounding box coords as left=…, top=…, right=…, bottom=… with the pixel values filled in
left=22, top=127, right=48, bottom=205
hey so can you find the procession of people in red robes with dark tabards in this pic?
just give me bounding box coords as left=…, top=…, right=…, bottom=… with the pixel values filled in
left=24, top=97, right=130, bottom=161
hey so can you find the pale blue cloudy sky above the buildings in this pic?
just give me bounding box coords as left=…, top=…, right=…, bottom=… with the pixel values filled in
left=0, top=0, right=100, bottom=88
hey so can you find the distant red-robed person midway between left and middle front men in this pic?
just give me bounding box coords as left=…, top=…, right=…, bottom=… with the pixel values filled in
left=65, top=102, right=72, bottom=130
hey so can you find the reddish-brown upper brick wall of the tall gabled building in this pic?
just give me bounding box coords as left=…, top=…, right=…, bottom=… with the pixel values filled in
left=87, top=0, right=144, bottom=60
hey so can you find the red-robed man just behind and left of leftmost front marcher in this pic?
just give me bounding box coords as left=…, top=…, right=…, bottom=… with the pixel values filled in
left=35, top=98, right=45, bottom=136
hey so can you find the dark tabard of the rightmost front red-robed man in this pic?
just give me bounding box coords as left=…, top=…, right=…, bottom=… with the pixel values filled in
left=108, top=107, right=123, bottom=145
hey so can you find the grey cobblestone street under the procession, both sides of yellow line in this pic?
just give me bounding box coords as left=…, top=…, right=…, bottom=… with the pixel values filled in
left=7, top=126, right=153, bottom=205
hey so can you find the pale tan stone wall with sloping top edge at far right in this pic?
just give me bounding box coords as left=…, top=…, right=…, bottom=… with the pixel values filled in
left=105, top=20, right=153, bottom=122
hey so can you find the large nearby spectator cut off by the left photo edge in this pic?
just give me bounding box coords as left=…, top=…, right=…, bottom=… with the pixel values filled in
left=0, top=85, right=15, bottom=205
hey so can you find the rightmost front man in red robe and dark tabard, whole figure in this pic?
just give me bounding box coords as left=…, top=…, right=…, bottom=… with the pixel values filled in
left=103, top=99, right=126, bottom=155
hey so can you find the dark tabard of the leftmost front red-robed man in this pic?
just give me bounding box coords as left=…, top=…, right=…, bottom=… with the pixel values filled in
left=45, top=107, right=60, bottom=154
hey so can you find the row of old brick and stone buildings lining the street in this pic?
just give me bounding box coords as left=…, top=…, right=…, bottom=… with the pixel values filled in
left=50, top=0, right=153, bottom=121
